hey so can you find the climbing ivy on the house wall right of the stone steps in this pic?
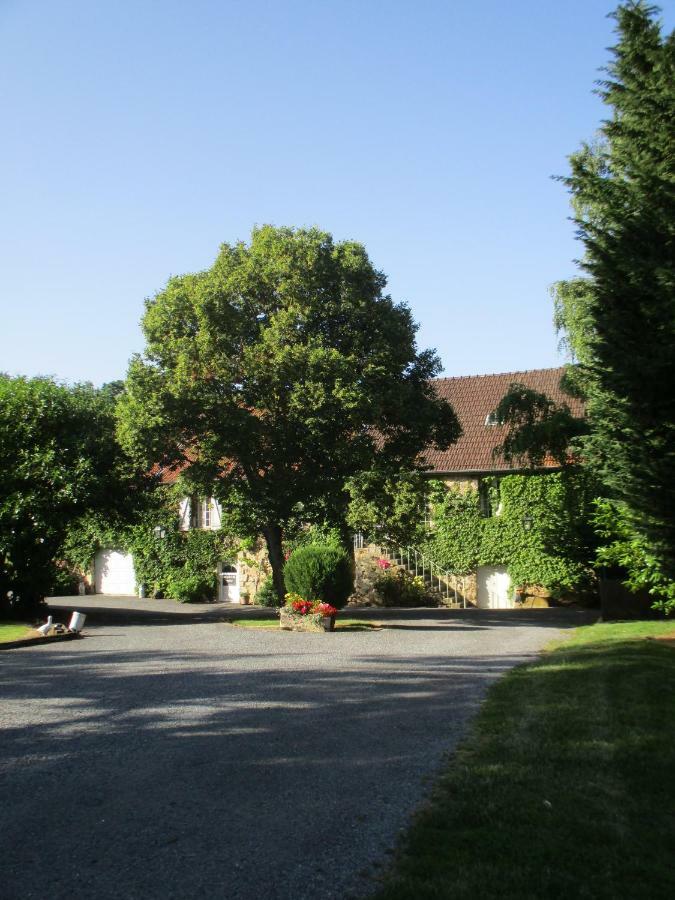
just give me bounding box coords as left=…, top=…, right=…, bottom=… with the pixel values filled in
left=427, top=470, right=597, bottom=596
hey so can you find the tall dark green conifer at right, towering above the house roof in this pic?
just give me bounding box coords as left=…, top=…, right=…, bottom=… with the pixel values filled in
left=500, top=2, right=675, bottom=599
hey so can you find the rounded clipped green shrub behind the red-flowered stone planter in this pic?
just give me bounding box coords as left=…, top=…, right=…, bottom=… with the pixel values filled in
left=284, top=544, right=354, bottom=609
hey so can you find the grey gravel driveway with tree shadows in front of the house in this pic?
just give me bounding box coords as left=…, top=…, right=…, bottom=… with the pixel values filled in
left=0, top=598, right=592, bottom=900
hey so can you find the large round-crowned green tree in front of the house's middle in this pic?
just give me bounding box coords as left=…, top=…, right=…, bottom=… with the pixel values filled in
left=119, top=226, right=459, bottom=596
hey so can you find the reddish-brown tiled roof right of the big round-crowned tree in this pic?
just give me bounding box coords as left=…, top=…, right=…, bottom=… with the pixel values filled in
left=424, top=366, right=584, bottom=474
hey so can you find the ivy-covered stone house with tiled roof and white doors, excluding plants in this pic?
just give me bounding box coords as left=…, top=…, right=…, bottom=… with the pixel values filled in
left=94, top=367, right=583, bottom=607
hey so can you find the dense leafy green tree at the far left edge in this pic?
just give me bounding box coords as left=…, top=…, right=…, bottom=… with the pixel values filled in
left=0, top=375, right=145, bottom=615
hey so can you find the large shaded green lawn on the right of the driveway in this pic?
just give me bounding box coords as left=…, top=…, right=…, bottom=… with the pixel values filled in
left=375, top=622, right=675, bottom=900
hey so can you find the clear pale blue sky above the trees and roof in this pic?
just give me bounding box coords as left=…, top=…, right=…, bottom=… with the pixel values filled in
left=0, top=0, right=674, bottom=384
